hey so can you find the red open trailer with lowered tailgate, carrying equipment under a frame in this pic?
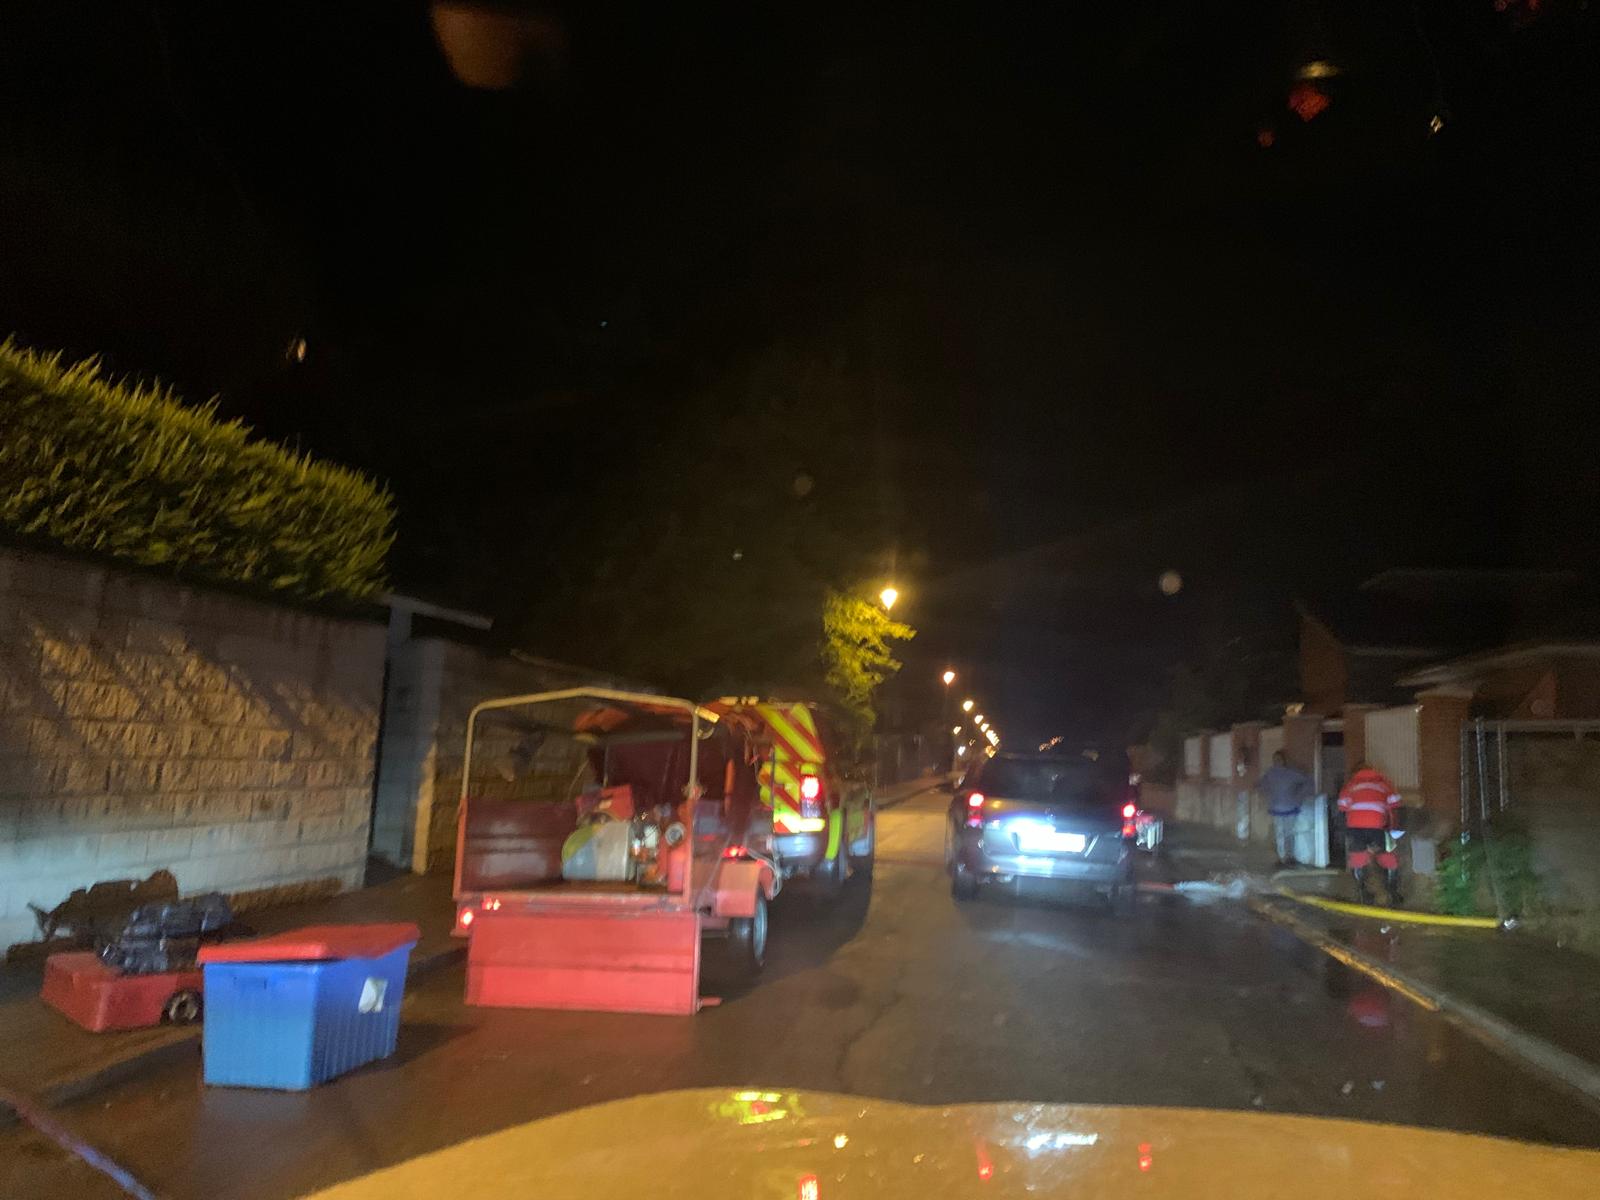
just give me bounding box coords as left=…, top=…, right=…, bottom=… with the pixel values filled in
left=454, top=688, right=781, bottom=1013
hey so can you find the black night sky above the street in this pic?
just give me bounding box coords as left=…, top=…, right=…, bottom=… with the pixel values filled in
left=0, top=0, right=1600, bottom=748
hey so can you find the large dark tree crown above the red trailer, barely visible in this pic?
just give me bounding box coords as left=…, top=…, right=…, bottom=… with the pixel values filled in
left=522, top=347, right=894, bottom=694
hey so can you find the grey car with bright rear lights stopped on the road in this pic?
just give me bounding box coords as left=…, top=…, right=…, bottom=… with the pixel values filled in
left=944, top=754, right=1138, bottom=912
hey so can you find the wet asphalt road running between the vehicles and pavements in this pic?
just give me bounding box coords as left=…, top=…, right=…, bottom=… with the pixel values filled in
left=9, top=792, right=1600, bottom=1200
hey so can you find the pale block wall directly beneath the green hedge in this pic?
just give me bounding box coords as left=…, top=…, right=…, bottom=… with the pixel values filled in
left=0, top=549, right=384, bottom=946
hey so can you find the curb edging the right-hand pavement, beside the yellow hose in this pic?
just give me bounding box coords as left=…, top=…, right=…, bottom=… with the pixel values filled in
left=1245, top=896, right=1600, bottom=1106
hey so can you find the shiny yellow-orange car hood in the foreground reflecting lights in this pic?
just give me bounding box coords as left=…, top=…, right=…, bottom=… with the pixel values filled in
left=302, top=1088, right=1600, bottom=1200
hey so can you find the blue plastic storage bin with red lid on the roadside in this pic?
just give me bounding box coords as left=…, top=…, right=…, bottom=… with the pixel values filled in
left=200, top=925, right=421, bottom=1091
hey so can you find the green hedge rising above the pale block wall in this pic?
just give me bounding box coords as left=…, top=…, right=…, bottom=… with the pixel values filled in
left=0, top=339, right=394, bottom=600
